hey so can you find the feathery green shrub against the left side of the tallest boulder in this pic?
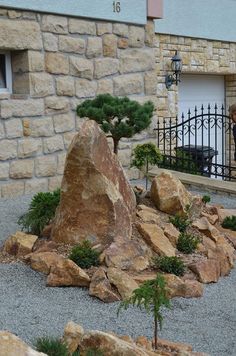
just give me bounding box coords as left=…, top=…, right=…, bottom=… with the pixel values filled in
left=17, top=189, right=60, bottom=235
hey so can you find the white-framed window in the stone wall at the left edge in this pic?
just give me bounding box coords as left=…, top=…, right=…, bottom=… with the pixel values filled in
left=0, top=52, right=12, bottom=93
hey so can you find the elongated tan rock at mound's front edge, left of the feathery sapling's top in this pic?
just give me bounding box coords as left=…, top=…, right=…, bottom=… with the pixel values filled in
left=107, top=267, right=138, bottom=299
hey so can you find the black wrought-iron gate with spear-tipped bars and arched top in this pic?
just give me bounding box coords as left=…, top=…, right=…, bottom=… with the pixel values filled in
left=154, top=105, right=236, bottom=180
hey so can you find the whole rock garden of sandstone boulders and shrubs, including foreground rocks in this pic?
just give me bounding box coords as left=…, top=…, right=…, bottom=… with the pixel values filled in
left=0, top=95, right=236, bottom=356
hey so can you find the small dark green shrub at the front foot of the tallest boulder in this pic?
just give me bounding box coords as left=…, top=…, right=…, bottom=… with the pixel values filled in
left=69, top=240, right=100, bottom=268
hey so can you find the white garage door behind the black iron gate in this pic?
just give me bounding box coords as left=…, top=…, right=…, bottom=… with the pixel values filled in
left=178, top=74, right=225, bottom=167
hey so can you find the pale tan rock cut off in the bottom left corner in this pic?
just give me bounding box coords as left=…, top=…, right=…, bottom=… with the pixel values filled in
left=0, top=330, right=47, bottom=356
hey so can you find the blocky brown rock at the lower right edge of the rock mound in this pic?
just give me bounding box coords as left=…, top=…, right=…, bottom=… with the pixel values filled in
left=188, top=259, right=220, bottom=283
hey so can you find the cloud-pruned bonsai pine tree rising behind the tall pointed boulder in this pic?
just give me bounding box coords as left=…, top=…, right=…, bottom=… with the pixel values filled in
left=77, top=94, right=154, bottom=154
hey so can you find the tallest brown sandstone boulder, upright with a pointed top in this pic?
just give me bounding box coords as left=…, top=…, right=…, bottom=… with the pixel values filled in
left=51, top=120, right=136, bottom=246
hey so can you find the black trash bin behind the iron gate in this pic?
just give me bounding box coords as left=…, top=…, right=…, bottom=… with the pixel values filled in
left=175, top=145, right=218, bottom=177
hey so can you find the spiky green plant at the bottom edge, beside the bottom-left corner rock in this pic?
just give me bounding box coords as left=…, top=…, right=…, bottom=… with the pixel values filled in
left=35, top=337, right=70, bottom=356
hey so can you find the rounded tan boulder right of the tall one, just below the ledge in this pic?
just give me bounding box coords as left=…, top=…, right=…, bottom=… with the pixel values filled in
left=151, top=172, right=192, bottom=215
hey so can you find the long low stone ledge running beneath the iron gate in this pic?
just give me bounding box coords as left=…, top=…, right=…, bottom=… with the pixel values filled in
left=148, top=168, right=236, bottom=196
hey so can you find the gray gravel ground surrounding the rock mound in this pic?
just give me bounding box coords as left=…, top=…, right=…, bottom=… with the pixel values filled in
left=0, top=192, right=236, bottom=356
